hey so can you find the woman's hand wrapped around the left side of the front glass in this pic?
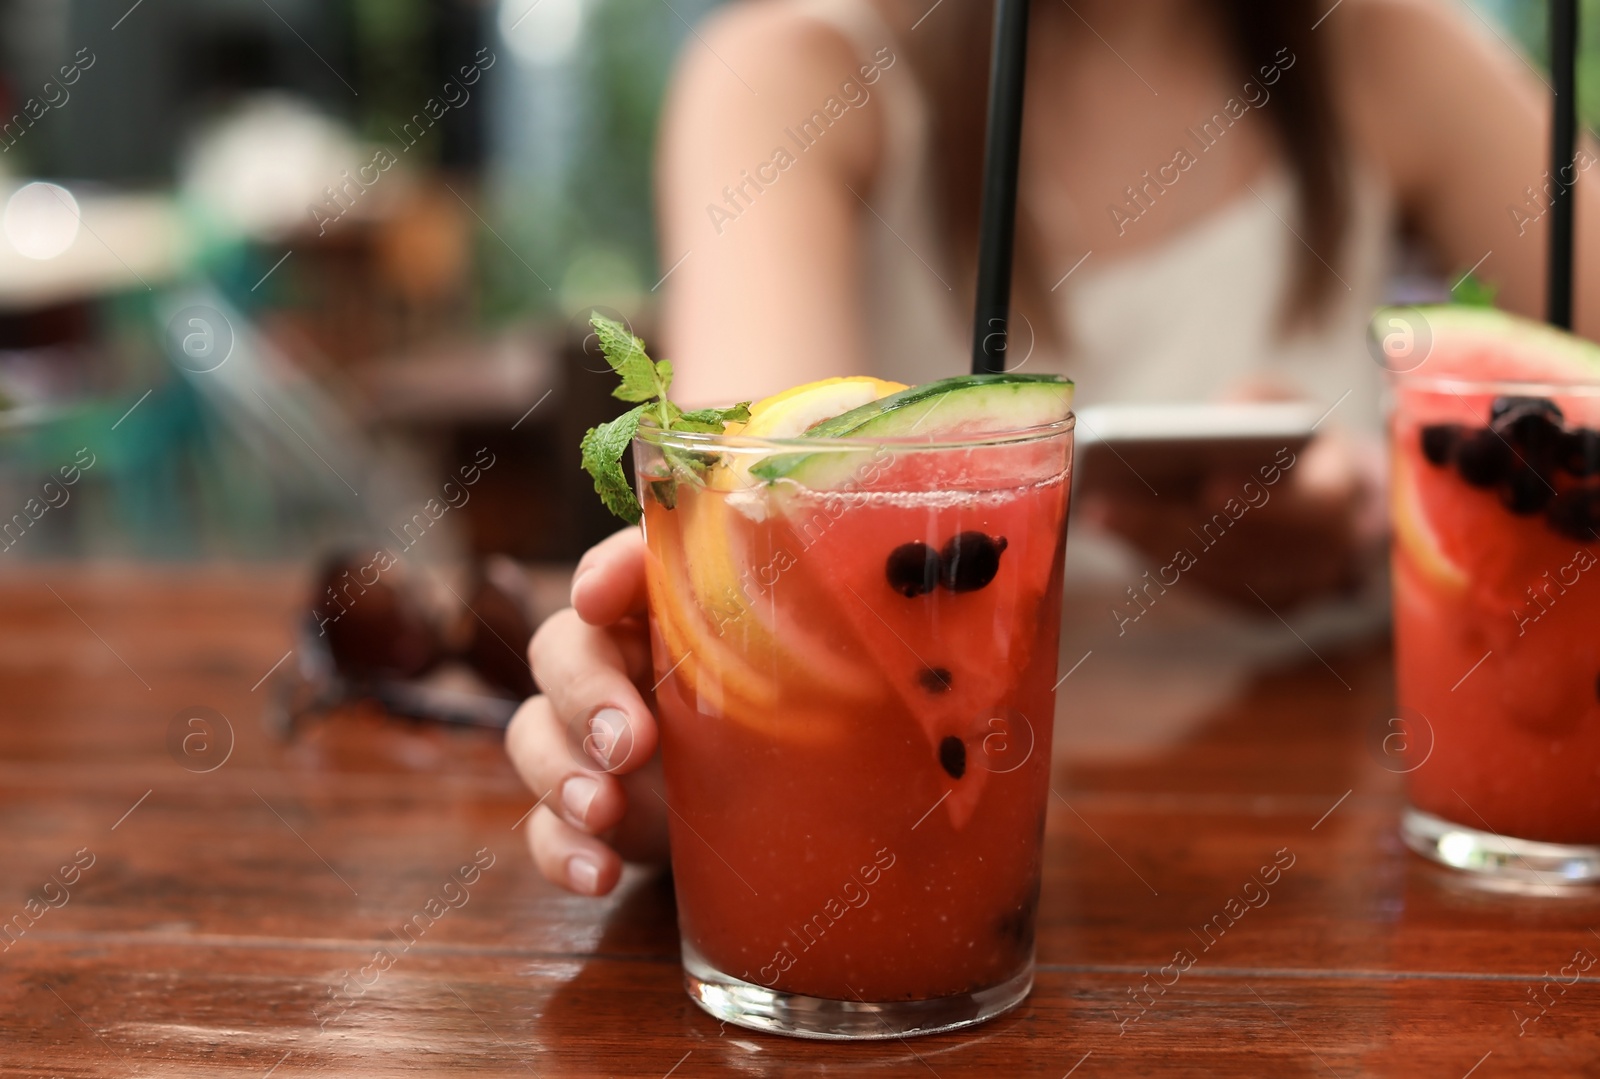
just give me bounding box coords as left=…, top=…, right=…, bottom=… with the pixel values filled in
left=506, top=528, right=667, bottom=895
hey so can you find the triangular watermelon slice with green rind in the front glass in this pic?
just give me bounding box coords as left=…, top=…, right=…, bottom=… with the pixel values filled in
left=750, top=375, right=1072, bottom=828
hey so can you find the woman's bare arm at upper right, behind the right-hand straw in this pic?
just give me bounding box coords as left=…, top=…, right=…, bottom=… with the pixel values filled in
left=1320, top=0, right=1600, bottom=338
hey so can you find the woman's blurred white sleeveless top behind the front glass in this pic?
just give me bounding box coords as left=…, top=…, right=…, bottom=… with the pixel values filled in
left=806, top=0, right=1394, bottom=431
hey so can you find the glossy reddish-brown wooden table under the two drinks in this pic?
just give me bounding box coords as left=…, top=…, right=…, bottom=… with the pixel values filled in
left=0, top=565, right=1600, bottom=1079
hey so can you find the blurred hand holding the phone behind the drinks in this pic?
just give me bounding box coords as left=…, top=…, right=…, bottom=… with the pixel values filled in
left=1080, top=435, right=1384, bottom=613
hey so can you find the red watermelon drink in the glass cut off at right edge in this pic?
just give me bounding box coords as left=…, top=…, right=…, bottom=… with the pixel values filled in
left=1378, top=307, right=1600, bottom=885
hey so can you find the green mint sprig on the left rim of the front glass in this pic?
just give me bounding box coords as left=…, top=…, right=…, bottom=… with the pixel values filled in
left=579, top=312, right=750, bottom=523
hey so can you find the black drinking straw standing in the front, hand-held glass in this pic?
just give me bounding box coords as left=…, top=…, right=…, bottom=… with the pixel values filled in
left=973, top=0, right=1030, bottom=375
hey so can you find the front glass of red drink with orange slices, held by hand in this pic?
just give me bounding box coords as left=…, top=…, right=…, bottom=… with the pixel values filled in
left=634, top=416, right=1074, bottom=1039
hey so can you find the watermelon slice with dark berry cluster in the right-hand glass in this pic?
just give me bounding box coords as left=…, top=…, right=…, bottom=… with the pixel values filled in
left=1374, top=307, right=1600, bottom=610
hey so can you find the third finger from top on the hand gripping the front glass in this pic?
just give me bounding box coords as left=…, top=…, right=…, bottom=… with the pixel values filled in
left=506, top=696, right=627, bottom=834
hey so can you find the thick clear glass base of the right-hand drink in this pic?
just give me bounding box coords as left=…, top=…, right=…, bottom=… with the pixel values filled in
left=1400, top=805, right=1600, bottom=890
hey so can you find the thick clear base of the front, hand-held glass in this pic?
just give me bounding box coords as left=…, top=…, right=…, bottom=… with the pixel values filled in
left=683, top=941, right=1034, bottom=1041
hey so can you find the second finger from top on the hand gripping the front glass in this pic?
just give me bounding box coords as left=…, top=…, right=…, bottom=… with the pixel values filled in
left=528, top=605, right=656, bottom=775
